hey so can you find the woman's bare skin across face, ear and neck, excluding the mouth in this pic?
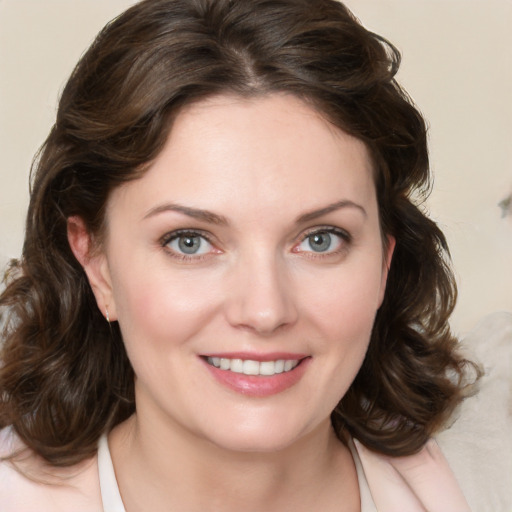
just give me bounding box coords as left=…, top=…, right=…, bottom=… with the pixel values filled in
left=68, top=95, right=394, bottom=512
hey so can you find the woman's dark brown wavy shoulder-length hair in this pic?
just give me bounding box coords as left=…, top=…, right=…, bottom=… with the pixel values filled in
left=0, top=0, right=478, bottom=466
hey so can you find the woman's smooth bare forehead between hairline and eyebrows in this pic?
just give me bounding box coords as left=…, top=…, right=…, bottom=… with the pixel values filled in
left=107, top=94, right=374, bottom=222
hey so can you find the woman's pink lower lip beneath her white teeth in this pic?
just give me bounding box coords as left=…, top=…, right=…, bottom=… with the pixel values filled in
left=201, top=357, right=311, bottom=397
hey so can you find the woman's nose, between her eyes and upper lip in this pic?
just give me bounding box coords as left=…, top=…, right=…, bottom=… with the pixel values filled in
left=225, top=250, right=298, bottom=336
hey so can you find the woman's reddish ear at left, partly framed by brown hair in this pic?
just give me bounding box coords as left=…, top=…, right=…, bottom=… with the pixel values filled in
left=67, top=216, right=117, bottom=321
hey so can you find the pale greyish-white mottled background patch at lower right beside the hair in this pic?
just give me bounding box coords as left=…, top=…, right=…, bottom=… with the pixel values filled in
left=437, top=312, right=512, bottom=512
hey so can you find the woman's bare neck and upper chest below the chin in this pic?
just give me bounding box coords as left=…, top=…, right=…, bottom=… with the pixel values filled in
left=109, top=415, right=359, bottom=512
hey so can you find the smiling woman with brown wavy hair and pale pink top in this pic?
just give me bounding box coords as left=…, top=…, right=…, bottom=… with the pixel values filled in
left=0, top=0, right=480, bottom=512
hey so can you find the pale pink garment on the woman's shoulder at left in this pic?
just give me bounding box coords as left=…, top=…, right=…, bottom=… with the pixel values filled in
left=0, top=428, right=102, bottom=512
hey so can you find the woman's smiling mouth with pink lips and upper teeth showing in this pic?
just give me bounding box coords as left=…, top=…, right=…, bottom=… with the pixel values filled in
left=201, top=353, right=311, bottom=397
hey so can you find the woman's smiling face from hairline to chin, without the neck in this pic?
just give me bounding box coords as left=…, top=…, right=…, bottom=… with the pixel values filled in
left=91, top=95, right=393, bottom=451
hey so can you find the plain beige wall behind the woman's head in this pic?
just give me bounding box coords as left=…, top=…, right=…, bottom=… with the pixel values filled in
left=0, top=0, right=512, bottom=333
